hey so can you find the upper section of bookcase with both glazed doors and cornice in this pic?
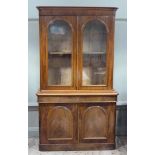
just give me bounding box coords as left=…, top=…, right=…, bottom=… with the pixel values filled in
left=39, top=7, right=116, bottom=90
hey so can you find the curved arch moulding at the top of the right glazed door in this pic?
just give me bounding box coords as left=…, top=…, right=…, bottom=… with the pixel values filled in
left=82, top=18, right=109, bottom=33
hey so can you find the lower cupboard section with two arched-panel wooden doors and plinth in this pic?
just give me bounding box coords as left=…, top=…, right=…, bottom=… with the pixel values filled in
left=39, top=103, right=115, bottom=150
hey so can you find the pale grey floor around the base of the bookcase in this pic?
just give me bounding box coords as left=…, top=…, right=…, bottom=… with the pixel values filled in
left=28, top=137, right=127, bottom=155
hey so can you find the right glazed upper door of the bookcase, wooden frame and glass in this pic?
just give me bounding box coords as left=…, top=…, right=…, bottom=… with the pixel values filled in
left=78, top=16, right=112, bottom=90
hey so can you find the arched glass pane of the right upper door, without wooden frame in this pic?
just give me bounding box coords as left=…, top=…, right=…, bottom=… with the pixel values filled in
left=82, top=20, right=107, bottom=85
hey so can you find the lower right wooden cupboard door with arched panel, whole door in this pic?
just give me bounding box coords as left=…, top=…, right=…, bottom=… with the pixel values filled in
left=78, top=103, right=116, bottom=143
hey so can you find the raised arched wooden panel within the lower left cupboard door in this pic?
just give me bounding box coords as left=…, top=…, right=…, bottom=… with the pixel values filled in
left=47, top=106, right=73, bottom=140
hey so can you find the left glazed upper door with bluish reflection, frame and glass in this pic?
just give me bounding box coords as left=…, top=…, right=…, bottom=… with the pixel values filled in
left=41, top=16, right=76, bottom=90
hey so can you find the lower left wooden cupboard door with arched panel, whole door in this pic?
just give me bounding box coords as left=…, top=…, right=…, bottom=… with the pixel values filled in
left=39, top=104, right=77, bottom=144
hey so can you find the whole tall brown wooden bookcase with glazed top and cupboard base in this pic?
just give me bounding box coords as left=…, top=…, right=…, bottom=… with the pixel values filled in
left=37, top=6, right=117, bottom=151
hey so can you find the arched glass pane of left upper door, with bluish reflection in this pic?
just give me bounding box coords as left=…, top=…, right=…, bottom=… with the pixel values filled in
left=48, top=20, right=72, bottom=86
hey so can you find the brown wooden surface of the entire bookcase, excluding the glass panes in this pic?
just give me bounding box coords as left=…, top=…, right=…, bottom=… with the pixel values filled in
left=37, top=6, right=118, bottom=151
